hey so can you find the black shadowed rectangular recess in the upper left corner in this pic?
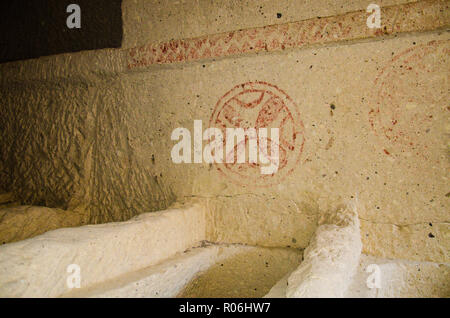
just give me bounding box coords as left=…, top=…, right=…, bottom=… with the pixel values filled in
left=0, top=0, right=122, bottom=63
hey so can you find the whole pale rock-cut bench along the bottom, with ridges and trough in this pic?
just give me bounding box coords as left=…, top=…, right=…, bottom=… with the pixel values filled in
left=0, top=202, right=450, bottom=297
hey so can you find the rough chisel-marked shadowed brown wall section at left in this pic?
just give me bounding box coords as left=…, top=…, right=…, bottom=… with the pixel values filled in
left=0, top=73, right=173, bottom=223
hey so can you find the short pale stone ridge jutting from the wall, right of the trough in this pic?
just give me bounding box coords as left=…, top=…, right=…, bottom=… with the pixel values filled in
left=286, top=202, right=362, bottom=298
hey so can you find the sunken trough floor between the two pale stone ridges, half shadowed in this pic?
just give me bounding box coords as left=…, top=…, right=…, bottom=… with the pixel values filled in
left=62, top=244, right=301, bottom=298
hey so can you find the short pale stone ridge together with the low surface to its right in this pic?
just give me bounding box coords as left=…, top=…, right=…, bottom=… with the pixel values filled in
left=265, top=200, right=450, bottom=298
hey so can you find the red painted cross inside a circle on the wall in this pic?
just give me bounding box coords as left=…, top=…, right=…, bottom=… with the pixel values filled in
left=210, top=82, right=305, bottom=187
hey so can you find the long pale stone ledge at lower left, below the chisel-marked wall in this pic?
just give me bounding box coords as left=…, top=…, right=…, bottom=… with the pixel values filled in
left=0, top=206, right=205, bottom=297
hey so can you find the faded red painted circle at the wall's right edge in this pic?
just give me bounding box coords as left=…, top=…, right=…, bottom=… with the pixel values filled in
left=369, top=40, right=450, bottom=159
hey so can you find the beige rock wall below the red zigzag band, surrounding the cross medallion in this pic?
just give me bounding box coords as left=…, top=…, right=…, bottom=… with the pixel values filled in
left=0, top=1, right=450, bottom=262
